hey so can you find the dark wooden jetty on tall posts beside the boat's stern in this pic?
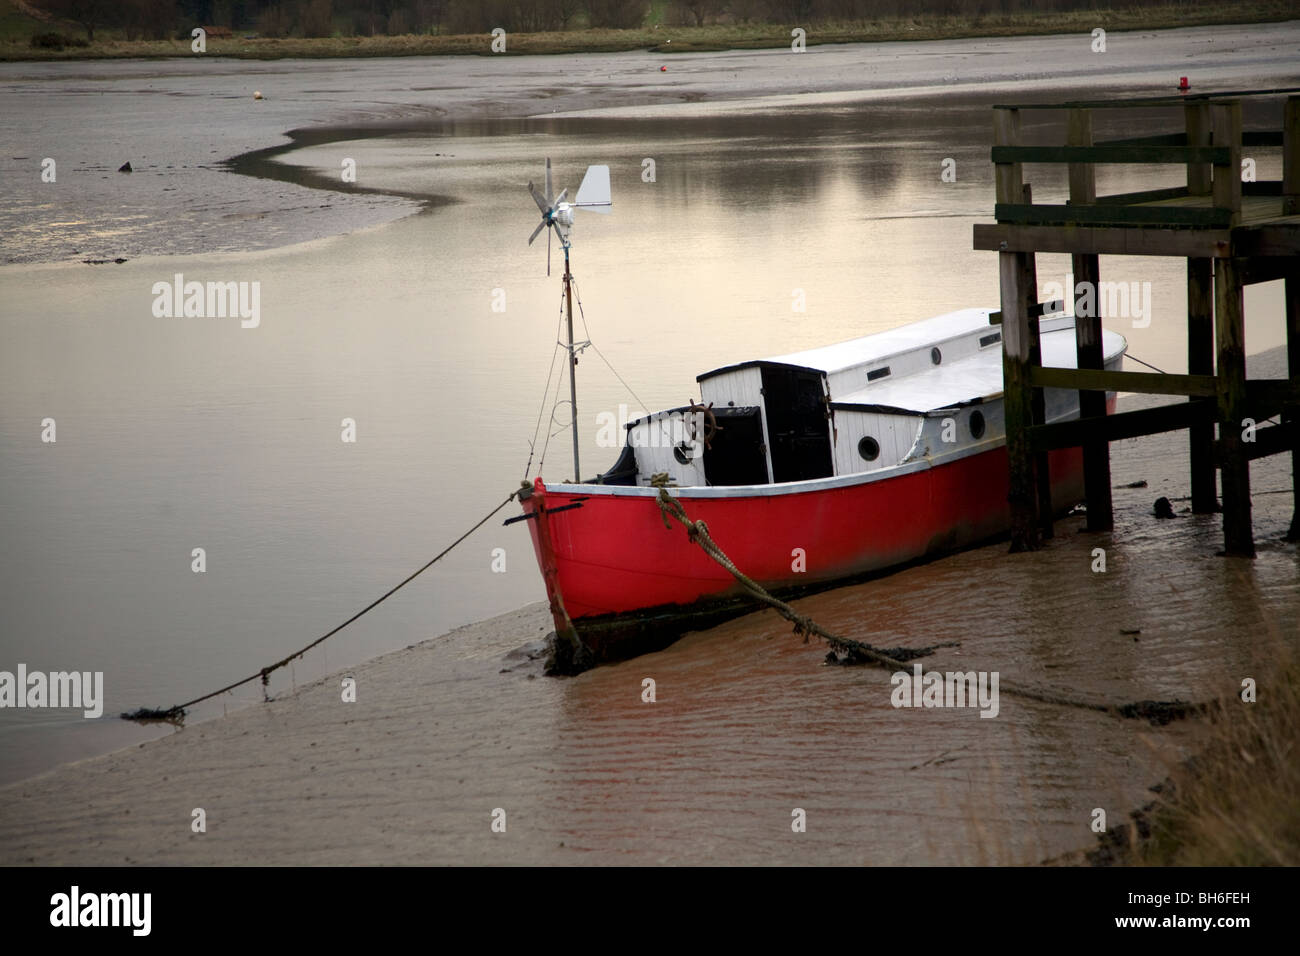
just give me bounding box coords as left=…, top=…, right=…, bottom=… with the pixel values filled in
left=975, top=88, right=1300, bottom=557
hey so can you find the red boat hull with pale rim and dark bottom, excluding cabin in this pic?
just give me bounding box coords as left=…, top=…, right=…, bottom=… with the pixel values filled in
left=523, top=434, right=1083, bottom=661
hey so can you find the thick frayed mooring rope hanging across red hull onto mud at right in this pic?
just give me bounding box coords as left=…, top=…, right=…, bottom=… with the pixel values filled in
left=651, top=486, right=1206, bottom=724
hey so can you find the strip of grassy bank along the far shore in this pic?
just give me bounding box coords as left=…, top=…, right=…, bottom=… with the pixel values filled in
left=0, top=0, right=1296, bottom=60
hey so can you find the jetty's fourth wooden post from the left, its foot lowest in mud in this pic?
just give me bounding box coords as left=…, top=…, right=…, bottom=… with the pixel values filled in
left=1210, top=100, right=1255, bottom=558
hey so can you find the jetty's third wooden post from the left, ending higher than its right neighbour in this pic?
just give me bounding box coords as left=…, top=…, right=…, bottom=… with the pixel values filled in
left=1183, top=101, right=1218, bottom=514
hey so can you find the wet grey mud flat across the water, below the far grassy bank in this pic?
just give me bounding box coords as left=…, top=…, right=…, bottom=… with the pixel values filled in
left=0, top=21, right=1300, bottom=268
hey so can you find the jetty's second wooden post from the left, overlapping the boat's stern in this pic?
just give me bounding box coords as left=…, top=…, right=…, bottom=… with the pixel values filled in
left=1066, top=109, right=1114, bottom=531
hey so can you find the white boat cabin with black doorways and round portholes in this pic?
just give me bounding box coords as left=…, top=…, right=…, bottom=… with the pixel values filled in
left=601, top=308, right=1127, bottom=486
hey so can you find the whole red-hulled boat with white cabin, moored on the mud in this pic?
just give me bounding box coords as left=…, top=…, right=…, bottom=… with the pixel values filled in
left=512, top=310, right=1127, bottom=662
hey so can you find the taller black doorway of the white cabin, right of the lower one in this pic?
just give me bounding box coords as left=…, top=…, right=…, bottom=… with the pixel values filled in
left=763, top=365, right=835, bottom=481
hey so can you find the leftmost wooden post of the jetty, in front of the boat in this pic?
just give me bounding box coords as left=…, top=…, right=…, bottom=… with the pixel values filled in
left=993, top=108, right=1040, bottom=551
